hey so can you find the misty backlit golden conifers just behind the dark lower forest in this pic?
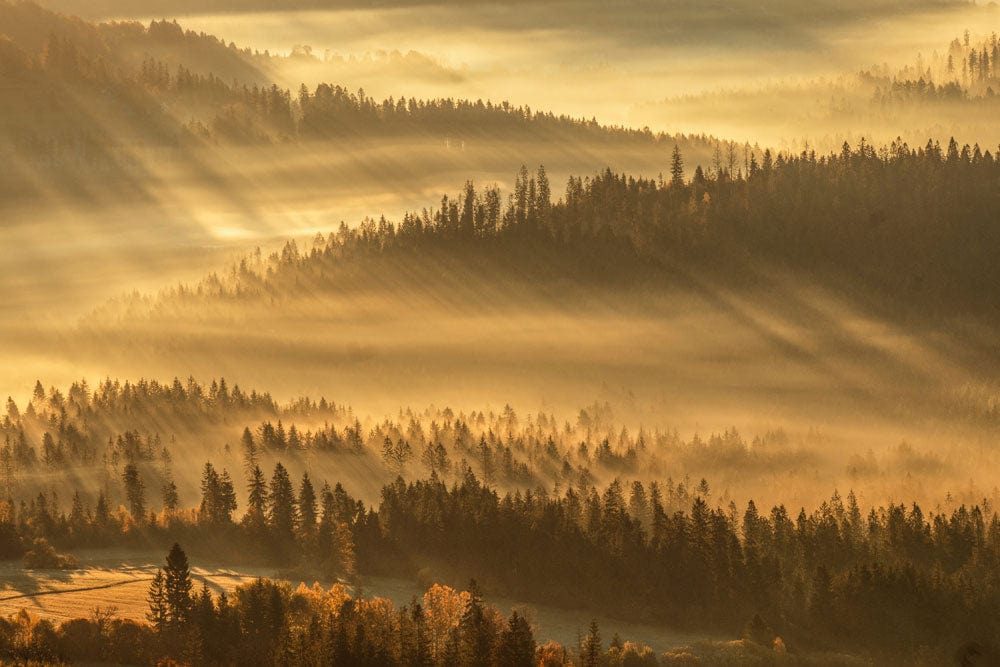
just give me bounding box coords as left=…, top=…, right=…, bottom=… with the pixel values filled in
left=0, top=379, right=832, bottom=520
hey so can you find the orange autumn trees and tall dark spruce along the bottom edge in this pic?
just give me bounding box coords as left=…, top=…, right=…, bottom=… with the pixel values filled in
left=57, top=544, right=552, bottom=667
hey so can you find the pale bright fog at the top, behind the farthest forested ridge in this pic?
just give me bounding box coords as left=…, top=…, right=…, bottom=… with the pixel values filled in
left=99, top=3, right=1000, bottom=148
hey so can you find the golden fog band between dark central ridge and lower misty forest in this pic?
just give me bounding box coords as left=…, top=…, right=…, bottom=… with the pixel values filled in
left=7, top=241, right=1000, bottom=505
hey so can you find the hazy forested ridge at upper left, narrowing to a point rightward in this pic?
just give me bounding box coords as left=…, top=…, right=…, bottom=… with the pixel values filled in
left=0, top=0, right=724, bottom=200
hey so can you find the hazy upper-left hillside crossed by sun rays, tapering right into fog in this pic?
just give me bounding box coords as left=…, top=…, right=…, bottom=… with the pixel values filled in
left=0, top=0, right=728, bottom=206
